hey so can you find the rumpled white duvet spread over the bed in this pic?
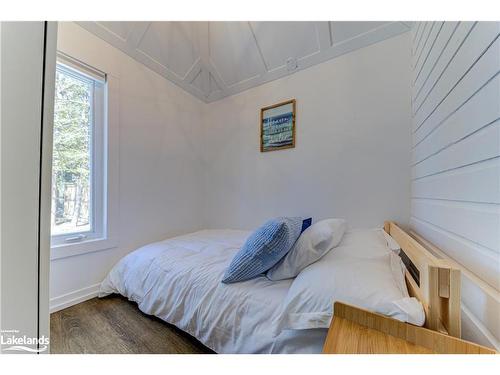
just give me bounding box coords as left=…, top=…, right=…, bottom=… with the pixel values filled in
left=100, top=230, right=326, bottom=353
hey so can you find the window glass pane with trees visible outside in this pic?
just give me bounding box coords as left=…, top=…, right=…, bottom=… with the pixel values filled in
left=51, top=66, right=94, bottom=236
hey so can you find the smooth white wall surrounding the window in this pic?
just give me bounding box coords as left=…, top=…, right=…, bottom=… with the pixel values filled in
left=50, top=22, right=205, bottom=309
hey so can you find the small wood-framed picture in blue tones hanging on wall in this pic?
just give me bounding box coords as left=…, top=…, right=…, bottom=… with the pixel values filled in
left=260, top=99, right=295, bottom=152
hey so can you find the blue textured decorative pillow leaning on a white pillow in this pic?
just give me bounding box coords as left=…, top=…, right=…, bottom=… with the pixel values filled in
left=222, top=217, right=302, bottom=284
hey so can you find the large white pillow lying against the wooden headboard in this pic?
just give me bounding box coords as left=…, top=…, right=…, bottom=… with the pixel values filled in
left=276, top=230, right=425, bottom=332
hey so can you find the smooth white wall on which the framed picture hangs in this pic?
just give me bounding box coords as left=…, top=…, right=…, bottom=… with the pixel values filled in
left=204, top=33, right=411, bottom=228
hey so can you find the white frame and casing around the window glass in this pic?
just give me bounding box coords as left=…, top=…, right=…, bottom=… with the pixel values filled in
left=51, top=52, right=119, bottom=260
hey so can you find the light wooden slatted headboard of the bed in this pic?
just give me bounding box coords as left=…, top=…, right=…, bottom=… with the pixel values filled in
left=384, top=221, right=461, bottom=337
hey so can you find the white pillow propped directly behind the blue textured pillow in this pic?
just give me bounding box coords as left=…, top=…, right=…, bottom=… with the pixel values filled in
left=267, top=219, right=347, bottom=281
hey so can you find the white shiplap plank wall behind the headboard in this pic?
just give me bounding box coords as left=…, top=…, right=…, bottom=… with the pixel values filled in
left=410, top=22, right=500, bottom=349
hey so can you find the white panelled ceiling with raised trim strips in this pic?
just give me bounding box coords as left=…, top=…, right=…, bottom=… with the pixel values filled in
left=75, top=22, right=410, bottom=103
